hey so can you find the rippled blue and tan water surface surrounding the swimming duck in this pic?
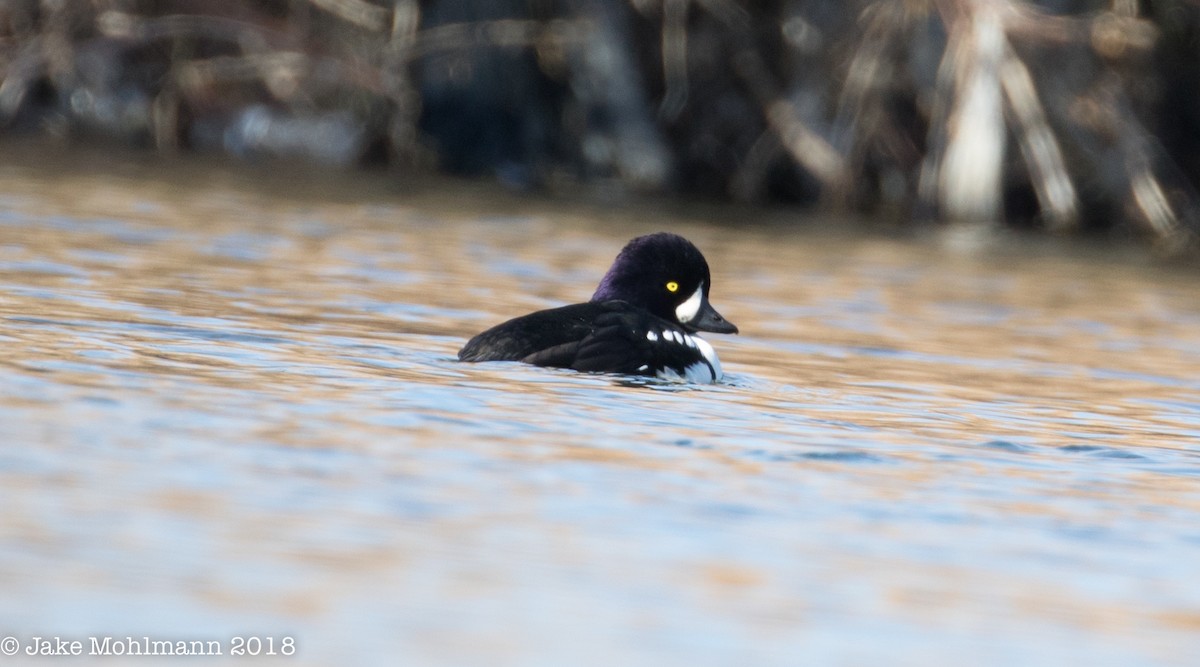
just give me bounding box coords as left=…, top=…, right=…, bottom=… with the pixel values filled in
left=0, top=148, right=1200, bottom=666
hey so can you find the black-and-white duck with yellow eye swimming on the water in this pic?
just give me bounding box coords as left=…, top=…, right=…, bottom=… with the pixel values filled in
left=458, top=232, right=738, bottom=384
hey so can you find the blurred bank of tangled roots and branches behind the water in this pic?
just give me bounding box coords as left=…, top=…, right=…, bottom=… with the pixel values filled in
left=0, top=0, right=1200, bottom=252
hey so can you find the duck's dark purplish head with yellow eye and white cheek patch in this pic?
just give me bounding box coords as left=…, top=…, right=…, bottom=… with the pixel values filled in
left=592, top=232, right=738, bottom=334
